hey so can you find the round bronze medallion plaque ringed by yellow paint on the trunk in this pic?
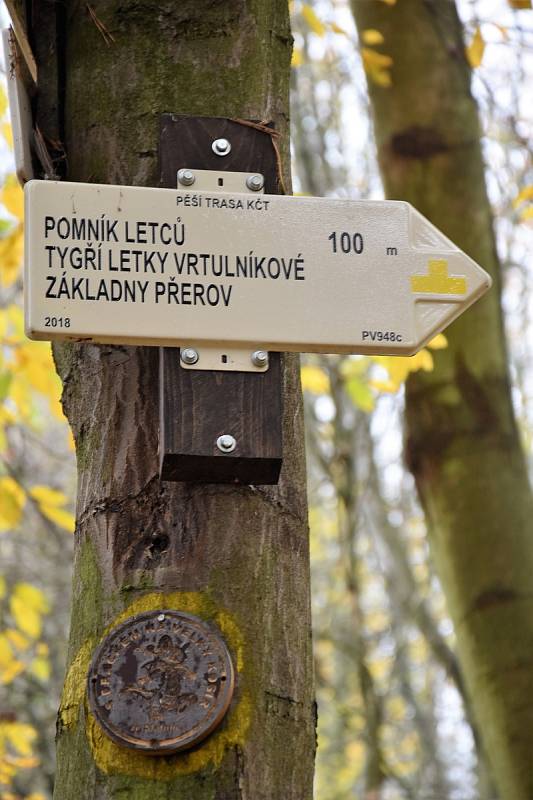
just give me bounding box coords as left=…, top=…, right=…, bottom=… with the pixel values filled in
left=88, top=610, right=234, bottom=755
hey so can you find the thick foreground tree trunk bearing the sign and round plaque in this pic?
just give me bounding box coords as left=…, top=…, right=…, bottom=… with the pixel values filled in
left=32, top=0, right=315, bottom=800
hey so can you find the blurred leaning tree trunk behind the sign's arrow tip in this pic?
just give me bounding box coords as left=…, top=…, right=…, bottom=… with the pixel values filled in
left=352, top=0, right=533, bottom=800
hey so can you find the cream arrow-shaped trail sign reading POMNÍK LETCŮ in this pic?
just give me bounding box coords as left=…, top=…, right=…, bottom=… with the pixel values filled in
left=25, top=181, right=491, bottom=355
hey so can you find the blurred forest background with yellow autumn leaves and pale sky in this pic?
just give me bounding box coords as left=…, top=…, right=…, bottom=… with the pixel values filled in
left=0, top=0, right=533, bottom=800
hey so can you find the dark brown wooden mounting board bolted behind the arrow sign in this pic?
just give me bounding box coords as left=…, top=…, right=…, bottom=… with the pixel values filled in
left=159, top=115, right=283, bottom=484
